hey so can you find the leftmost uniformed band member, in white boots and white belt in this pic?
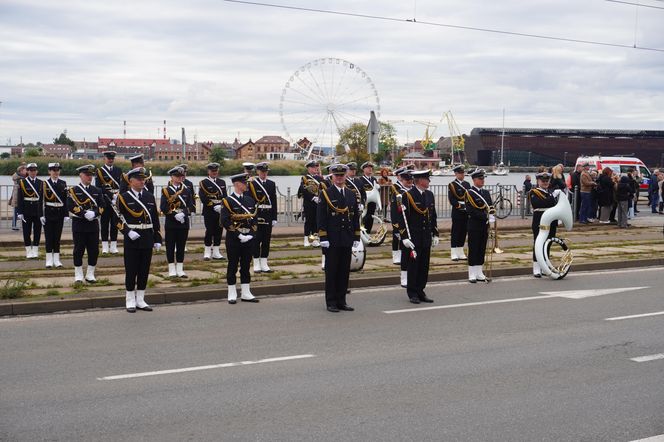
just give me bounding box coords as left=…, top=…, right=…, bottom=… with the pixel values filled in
left=16, top=163, right=44, bottom=259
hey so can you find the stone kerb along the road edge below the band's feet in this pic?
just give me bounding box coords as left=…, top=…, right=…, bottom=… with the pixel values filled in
left=0, top=258, right=664, bottom=316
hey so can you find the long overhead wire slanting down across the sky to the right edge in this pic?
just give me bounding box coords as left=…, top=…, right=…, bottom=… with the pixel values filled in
left=223, top=0, right=664, bottom=52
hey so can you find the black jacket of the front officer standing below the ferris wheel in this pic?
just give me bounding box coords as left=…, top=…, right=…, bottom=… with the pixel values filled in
left=316, top=186, right=360, bottom=247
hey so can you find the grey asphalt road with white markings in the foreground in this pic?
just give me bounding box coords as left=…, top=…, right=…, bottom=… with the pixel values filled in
left=0, top=269, right=664, bottom=441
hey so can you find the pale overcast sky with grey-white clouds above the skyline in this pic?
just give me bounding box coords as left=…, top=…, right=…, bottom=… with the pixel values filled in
left=0, top=0, right=664, bottom=144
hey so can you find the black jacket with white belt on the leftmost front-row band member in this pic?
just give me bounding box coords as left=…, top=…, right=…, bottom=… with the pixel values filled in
left=117, top=189, right=161, bottom=249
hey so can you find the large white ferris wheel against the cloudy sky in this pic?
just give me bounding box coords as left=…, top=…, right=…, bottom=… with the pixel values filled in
left=279, top=58, right=380, bottom=157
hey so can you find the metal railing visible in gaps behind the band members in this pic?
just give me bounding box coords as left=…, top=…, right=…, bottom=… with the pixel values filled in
left=0, top=184, right=527, bottom=230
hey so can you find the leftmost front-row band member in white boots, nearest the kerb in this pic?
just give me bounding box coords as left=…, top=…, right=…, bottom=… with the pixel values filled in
left=117, top=167, right=161, bottom=313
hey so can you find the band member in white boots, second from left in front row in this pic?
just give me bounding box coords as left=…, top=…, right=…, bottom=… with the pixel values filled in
left=221, top=173, right=258, bottom=304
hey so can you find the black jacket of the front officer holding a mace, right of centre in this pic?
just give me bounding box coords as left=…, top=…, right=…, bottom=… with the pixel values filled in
left=397, top=186, right=438, bottom=248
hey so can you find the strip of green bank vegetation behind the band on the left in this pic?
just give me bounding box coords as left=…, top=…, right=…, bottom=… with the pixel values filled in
left=0, top=156, right=306, bottom=176
